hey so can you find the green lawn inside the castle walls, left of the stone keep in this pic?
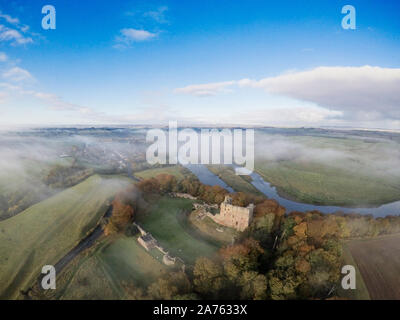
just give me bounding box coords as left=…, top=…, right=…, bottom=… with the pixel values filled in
left=137, top=197, right=218, bottom=264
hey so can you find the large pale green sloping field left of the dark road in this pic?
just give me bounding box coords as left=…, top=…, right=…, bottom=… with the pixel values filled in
left=0, top=175, right=128, bottom=299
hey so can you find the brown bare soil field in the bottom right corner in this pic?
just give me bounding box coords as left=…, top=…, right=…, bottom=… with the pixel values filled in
left=347, top=235, right=400, bottom=300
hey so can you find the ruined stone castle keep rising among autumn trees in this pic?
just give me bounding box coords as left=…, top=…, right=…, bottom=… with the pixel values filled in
left=214, top=195, right=254, bottom=231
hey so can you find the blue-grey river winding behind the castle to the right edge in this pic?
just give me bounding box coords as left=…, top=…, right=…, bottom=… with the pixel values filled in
left=185, top=164, right=400, bottom=217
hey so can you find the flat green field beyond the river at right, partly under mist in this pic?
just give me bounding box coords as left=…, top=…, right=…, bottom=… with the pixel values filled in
left=255, top=137, right=400, bottom=206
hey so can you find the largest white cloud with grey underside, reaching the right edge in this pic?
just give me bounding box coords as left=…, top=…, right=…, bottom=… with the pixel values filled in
left=238, top=66, right=400, bottom=120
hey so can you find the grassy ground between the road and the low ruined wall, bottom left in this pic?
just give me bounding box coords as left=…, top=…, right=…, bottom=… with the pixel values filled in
left=51, top=236, right=168, bottom=300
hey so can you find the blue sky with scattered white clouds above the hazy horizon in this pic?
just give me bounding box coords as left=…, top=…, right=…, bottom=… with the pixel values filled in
left=0, top=0, right=400, bottom=129
